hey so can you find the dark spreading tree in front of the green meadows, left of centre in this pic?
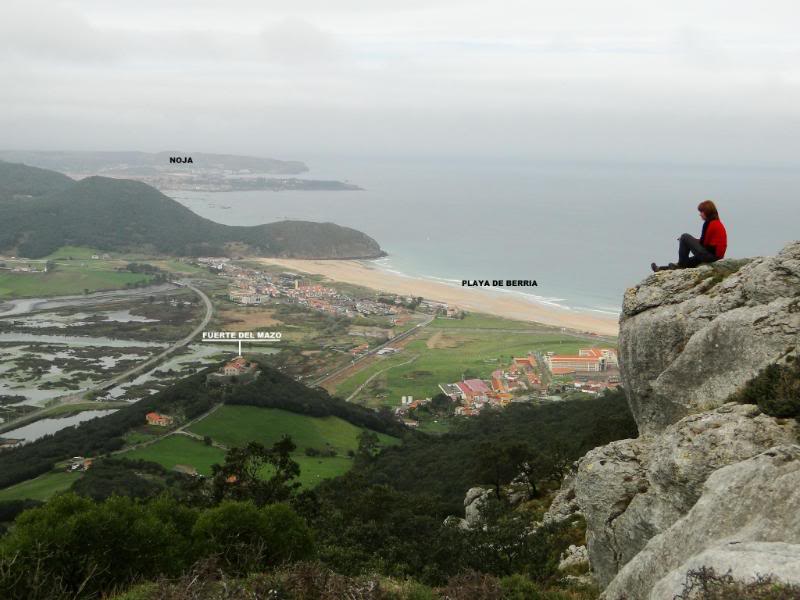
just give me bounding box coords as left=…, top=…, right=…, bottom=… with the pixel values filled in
left=211, top=436, right=300, bottom=506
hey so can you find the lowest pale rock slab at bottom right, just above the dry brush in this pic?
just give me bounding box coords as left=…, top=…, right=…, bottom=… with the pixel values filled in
left=649, top=541, right=800, bottom=600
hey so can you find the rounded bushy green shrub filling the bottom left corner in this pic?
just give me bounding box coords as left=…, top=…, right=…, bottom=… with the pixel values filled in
left=0, top=493, right=188, bottom=598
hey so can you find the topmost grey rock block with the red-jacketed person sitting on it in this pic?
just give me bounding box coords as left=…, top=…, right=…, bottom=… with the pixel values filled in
left=619, top=242, right=800, bottom=434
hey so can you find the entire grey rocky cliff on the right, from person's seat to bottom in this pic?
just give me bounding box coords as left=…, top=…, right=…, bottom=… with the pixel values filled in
left=551, top=242, right=800, bottom=600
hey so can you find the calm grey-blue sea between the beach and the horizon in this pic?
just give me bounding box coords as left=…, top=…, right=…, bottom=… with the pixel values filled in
left=166, top=157, right=800, bottom=315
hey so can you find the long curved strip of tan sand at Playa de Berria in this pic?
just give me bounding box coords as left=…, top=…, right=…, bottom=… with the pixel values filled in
left=255, top=258, right=619, bottom=336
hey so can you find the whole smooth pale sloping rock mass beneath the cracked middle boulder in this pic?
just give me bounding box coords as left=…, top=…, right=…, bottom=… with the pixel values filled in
left=603, top=445, right=800, bottom=600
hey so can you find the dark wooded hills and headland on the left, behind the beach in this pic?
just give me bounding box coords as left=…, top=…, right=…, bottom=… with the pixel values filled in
left=0, top=163, right=383, bottom=258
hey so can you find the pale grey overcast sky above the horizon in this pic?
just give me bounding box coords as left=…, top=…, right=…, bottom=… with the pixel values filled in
left=0, top=0, right=800, bottom=165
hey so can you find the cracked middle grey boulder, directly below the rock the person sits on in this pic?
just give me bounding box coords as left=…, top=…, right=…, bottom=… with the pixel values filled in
left=576, top=403, right=800, bottom=585
